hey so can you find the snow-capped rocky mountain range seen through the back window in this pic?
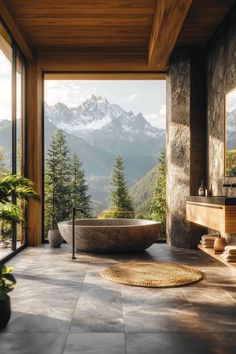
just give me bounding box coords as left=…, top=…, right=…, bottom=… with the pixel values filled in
left=45, top=95, right=165, bottom=156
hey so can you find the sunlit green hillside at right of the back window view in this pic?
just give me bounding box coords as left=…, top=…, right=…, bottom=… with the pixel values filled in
left=129, top=165, right=158, bottom=214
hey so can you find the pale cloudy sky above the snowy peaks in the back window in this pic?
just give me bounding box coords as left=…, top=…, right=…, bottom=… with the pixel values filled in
left=44, top=80, right=166, bottom=129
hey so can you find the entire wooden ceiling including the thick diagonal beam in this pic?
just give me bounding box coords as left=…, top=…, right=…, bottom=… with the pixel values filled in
left=0, top=0, right=235, bottom=72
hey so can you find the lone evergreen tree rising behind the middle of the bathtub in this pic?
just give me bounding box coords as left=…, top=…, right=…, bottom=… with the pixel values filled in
left=110, top=156, right=134, bottom=217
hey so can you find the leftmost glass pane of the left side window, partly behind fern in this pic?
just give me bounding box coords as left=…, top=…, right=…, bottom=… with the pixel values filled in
left=0, top=23, right=13, bottom=258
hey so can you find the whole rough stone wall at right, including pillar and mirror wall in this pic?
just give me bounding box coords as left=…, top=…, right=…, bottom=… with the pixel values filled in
left=167, top=6, right=236, bottom=247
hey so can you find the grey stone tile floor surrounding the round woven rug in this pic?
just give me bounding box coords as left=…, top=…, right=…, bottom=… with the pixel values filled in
left=0, top=244, right=236, bottom=354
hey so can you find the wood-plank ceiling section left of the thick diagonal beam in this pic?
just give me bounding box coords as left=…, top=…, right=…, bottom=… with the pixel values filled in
left=6, top=0, right=157, bottom=51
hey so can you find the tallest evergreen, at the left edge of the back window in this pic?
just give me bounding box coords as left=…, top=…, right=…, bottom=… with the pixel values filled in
left=45, top=130, right=72, bottom=232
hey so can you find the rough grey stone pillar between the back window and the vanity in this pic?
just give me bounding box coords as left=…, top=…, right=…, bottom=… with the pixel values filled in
left=167, top=47, right=206, bottom=248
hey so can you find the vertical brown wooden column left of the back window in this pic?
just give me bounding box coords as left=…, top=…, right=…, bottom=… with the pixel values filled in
left=26, top=61, right=43, bottom=246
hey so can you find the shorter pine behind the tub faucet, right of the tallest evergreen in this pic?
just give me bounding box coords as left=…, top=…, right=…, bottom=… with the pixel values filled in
left=71, top=154, right=91, bottom=218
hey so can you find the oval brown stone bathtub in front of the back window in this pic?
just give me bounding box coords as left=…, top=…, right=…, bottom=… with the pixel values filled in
left=58, top=219, right=161, bottom=253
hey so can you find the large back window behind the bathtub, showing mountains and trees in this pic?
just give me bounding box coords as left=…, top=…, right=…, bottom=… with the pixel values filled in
left=44, top=78, right=166, bottom=239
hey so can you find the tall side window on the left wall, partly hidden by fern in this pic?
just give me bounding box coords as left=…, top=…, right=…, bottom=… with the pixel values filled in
left=0, top=22, right=25, bottom=259
